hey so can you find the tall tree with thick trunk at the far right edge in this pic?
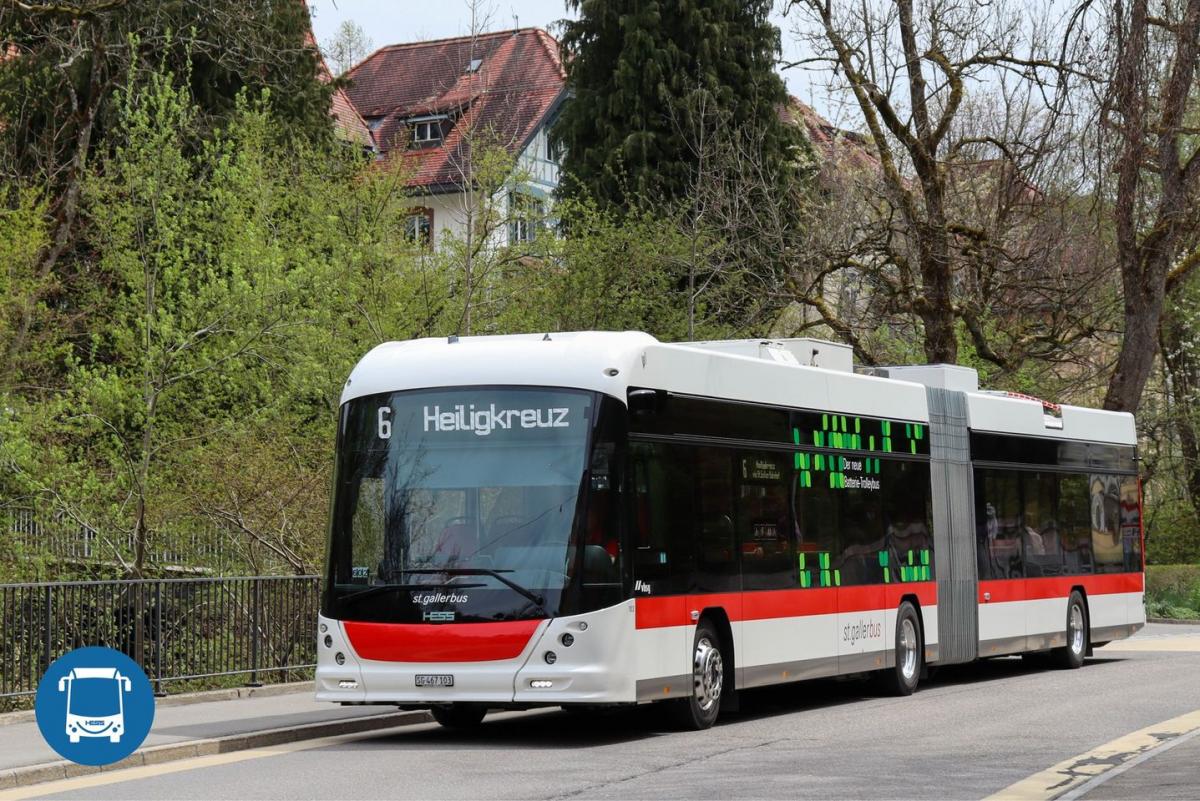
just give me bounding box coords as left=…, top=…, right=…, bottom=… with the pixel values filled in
left=1085, top=0, right=1200, bottom=411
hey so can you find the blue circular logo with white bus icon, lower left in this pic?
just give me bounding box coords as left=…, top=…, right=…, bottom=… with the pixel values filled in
left=34, top=648, right=154, bottom=765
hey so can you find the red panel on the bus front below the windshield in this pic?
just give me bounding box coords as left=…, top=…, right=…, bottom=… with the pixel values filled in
left=342, top=620, right=541, bottom=662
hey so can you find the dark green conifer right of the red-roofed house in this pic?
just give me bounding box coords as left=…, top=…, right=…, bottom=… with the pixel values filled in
left=554, top=0, right=797, bottom=209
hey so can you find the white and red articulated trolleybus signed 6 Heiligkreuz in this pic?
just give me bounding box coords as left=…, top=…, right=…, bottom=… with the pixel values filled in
left=317, top=332, right=1145, bottom=728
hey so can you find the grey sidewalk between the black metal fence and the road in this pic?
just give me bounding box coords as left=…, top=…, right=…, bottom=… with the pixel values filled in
left=0, top=682, right=430, bottom=788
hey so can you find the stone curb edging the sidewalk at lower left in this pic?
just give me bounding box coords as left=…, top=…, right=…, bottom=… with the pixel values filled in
left=0, top=709, right=433, bottom=790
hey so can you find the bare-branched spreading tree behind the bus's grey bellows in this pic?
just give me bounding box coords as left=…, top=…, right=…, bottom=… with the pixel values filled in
left=788, top=0, right=1096, bottom=371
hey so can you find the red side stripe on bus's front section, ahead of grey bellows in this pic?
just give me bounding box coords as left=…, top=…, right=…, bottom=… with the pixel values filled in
left=635, top=582, right=937, bottom=628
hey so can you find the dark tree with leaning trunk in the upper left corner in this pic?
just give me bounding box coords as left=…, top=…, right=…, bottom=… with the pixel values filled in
left=0, top=0, right=332, bottom=381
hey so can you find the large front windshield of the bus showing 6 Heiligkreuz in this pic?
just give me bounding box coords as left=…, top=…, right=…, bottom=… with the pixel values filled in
left=325, top=387, right=595, bottom=622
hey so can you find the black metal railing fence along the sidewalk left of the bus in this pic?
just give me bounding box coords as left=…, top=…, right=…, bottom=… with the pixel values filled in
left=0, top=576, right=320, bottom=698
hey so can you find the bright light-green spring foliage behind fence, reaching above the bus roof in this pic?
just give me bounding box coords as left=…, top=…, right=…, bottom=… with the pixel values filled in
left=0, top=56, right=730, bottom=578
